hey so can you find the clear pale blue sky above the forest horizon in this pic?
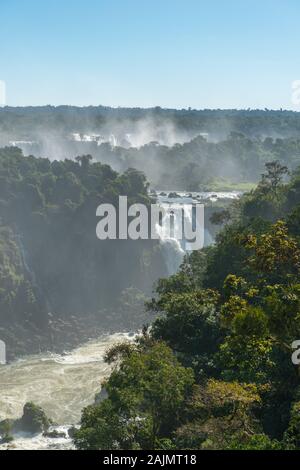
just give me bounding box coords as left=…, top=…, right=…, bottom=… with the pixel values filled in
left=0, top=0, right=300, bottom=109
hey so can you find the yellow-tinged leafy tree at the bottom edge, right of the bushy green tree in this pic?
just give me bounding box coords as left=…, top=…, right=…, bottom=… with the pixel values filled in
left=175, top=379, right=261, bottom=449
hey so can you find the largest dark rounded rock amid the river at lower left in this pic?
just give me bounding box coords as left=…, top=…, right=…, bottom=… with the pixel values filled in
left=13, top=402, right=52, bottom=434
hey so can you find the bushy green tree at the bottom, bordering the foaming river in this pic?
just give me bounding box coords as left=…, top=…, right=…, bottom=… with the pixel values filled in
left=75, top=342, right=194, bottom=450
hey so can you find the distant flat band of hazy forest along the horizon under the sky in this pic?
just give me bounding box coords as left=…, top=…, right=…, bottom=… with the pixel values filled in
left=0, top=106, right=300, bottom=138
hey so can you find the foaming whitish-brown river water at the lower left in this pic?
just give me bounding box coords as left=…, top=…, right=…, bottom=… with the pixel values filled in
left=0, top=334, right=134, bottom=450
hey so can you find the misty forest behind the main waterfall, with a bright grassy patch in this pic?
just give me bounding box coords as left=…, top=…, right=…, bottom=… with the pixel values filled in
left=93, top=132, right=300, bottom=191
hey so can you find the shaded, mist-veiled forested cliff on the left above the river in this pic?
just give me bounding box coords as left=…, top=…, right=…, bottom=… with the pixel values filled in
left=0, top=148, right=167, bottom=355
